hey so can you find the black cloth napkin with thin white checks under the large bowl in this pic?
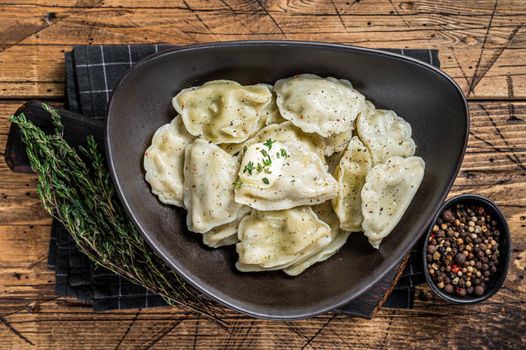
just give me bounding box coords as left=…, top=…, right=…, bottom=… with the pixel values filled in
left=48, top=44, right=440, bottom=313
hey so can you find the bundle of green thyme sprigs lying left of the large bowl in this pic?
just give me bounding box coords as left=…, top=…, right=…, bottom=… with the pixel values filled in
left=11, top=104, right=225, bottom=326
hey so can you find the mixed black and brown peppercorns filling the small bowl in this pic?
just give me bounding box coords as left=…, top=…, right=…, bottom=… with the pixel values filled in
left=427, top=204, right=500, bottom=297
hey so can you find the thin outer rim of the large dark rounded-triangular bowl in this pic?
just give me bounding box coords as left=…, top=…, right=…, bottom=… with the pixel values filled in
left=104, top=40, right=470, bottom=320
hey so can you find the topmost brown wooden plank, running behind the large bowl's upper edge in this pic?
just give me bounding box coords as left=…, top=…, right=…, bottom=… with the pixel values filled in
left=0, top=0, right=526, bottom=99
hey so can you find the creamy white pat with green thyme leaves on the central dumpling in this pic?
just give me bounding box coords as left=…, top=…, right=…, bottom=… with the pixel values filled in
left=239, top=141, right=288, bottom=188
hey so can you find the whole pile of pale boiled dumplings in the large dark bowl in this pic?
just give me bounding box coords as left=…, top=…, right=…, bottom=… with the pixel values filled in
left=144, top=74, right=425, bottom=276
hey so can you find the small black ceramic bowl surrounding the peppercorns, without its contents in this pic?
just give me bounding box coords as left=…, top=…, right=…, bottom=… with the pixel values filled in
left=422, top=194, right=511, bottom=304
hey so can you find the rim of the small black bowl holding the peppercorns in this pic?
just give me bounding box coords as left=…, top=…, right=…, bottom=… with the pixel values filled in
left=422, top=193, right=512, bottom=305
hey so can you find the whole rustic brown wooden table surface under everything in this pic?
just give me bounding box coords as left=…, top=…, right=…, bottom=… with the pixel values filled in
left=0, top=0, right=526, bottom=349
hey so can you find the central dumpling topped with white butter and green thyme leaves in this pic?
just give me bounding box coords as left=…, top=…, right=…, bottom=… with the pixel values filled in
left=235, top=139, right=338, bottom=210
